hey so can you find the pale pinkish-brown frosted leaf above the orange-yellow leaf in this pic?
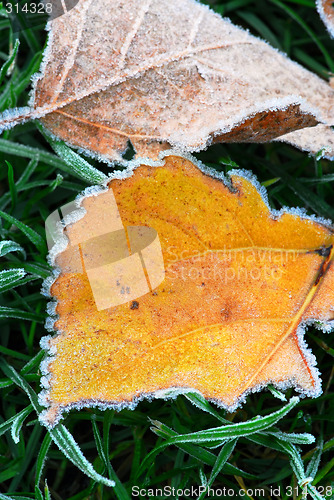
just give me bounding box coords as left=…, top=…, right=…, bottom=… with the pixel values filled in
left=0, top=0, right=334, bottom=160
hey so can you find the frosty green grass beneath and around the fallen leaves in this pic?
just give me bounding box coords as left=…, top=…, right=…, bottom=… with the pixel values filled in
left=0, top=0, right=334, bottom=500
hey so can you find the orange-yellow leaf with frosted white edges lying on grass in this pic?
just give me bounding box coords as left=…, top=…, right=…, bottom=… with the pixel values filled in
left=41, top=156, right=334, bottom=426
